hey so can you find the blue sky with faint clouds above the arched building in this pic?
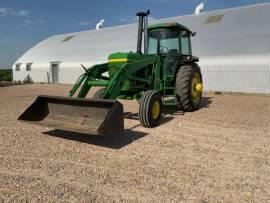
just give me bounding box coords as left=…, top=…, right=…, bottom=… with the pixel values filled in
left=0, top=0, right=270, bottom=68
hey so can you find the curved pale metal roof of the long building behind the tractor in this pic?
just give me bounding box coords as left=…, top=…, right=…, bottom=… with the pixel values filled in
left=16, top=3, right=270, bottom=63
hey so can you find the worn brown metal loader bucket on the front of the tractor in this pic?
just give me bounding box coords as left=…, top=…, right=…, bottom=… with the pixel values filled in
left=18, top=96, right=124, bottom=135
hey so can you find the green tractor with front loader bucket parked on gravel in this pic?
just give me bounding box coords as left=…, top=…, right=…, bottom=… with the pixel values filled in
left=19, top=11, right=203, bottom=135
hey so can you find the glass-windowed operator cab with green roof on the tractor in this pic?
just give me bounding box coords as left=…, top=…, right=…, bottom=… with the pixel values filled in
left=148, top=22, right=198, bottom=75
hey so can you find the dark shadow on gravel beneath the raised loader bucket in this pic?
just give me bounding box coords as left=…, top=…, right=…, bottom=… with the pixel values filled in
left=43, top=126, right=147, bottom=149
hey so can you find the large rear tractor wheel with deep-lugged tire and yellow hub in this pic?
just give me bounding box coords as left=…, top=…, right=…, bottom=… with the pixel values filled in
left=176, top=64, right=203, bottom=111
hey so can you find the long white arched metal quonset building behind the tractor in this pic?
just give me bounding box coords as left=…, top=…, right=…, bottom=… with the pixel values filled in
left=13, top=4, right=270, bottom=94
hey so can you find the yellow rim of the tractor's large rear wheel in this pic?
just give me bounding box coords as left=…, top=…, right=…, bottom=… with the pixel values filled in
left=190, top=72, right=203, bottom=103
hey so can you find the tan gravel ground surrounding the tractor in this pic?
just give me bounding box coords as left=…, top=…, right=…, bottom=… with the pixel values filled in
left=0, top=84, right=270, bottom=203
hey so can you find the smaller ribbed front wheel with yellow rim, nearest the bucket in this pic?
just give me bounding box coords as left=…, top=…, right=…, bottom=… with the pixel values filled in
left=139, top=90, right=162, bottom=128
